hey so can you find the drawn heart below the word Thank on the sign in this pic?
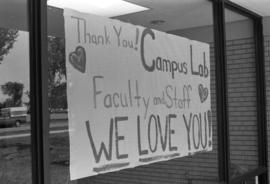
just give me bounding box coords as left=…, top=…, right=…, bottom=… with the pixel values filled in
left=69, top=46, right=86, bottom=73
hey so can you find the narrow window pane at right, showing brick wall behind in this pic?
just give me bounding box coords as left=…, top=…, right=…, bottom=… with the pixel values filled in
left=225, top=10, right=258, bottom=178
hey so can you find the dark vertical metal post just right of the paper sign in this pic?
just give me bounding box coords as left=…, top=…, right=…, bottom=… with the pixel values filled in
left=213, top=0, right=229, bottom=183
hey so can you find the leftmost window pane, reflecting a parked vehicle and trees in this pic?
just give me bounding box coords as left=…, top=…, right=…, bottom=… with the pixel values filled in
left=0, top=0, right=32, bottom=184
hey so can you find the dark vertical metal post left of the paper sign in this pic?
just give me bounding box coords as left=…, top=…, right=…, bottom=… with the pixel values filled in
left=28, top=0, right=50, bottom=184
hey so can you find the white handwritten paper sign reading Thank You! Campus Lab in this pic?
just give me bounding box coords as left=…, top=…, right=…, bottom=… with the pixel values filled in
left=64, top=9, right=212, bottom=180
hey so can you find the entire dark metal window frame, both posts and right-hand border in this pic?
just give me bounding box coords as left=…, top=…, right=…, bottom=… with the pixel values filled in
left=28, top=0, right=268, bottom=184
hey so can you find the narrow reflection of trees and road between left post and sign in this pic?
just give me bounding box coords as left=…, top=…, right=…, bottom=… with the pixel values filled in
left=48, top=36, right=69, bottom=184
